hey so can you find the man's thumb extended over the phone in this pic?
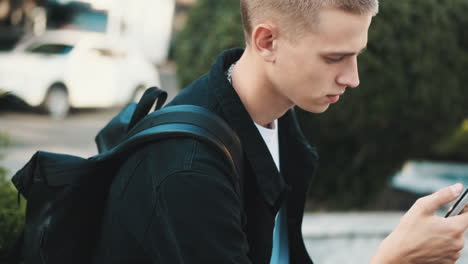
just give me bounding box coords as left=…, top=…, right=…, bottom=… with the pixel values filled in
left=421, top=183, right=463, bottom=213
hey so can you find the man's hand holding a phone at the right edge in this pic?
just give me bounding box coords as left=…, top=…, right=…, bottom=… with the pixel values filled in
left=371, top=184, right=468, bottom=264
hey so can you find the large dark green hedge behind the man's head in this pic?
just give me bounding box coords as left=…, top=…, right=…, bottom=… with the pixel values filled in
left=175, top=0, right=468, bottom=208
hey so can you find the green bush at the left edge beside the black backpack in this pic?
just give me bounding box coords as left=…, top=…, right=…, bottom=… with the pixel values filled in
left=0, top=133, right=26, bottom=256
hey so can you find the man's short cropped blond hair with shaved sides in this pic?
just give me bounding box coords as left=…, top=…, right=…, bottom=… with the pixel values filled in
left=240, top=0, right=379, bottom=43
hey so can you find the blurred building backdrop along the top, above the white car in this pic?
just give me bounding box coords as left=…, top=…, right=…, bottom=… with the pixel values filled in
left=0, top=0, right=176, bottom=64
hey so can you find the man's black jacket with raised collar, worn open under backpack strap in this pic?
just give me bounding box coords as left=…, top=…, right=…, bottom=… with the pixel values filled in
left=92, top=49, right=318, bottom=264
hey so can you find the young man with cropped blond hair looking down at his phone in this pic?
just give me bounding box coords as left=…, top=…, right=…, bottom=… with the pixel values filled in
left=96, top=0, right=468, bottom=264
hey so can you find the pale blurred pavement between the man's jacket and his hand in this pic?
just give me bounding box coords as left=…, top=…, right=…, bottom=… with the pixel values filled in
left=302, top=212, right=398, bottom=264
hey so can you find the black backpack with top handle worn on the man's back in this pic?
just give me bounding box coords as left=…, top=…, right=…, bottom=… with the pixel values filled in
left=3, top=88, right=242, bottom=264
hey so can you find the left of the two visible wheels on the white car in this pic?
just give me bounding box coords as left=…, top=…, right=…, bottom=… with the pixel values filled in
left=44, top=85, right=70, bottom=119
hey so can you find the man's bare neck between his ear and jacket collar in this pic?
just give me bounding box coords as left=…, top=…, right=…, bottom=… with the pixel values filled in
left=232, top=48, right=293, bottom=127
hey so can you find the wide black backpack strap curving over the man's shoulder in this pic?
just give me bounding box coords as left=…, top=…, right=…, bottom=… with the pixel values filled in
left=92, top=105, right=243, bottom=186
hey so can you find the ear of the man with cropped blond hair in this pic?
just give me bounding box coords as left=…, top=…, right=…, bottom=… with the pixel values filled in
left=252, top=24, right=278, bottom=62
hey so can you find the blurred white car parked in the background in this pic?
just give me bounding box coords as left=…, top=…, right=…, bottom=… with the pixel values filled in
left=0, top=30, right=160, bottom=118
